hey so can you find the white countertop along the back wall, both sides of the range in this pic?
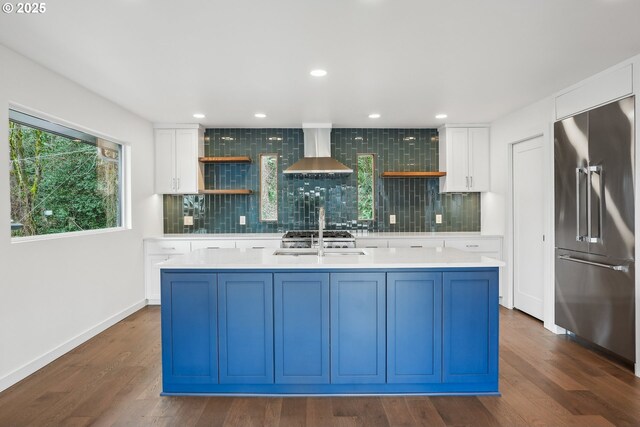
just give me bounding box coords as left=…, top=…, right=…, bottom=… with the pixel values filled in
left=145, top=231, right=502, bottom=240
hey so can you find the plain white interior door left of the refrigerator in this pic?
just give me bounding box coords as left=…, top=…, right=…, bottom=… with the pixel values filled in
left=512, top=137, right=544, bottom=320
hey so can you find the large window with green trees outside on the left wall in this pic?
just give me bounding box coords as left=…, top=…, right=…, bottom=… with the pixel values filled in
left=9, top=110, right=123, bottom=237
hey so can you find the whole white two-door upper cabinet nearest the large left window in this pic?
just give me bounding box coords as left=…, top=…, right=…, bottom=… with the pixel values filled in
left=155, top=125, right=204, bottom=194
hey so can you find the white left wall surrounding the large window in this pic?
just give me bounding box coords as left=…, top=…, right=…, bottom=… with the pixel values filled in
left=0, top=45, right=162, bottom=390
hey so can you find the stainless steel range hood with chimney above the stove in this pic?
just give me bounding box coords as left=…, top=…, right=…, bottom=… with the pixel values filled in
left=284, top=123, right=353, bottom=174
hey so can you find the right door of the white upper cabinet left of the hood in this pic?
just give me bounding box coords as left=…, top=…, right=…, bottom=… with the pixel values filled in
left=175, top=129, right=198, bottom=194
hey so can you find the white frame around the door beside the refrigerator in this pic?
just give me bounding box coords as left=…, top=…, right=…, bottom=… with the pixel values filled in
left=502, top=128, right=564, bottom=333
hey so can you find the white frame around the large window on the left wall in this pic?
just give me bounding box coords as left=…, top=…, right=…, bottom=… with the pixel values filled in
left=6, top=103, right=132, bottom=244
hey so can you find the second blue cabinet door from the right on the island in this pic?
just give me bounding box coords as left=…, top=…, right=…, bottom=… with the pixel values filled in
left=387, top=272, right=442, bottom=384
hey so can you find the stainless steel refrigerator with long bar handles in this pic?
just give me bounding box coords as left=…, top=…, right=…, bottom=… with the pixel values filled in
left=554, top=97, right=636, bottom=362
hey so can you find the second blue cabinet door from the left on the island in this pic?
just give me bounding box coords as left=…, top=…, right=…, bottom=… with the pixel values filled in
left=218, top=273, right=273, bottom=384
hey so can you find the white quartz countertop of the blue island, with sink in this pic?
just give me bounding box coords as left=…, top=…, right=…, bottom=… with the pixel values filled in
left=159, top=248, right=505, bottom=270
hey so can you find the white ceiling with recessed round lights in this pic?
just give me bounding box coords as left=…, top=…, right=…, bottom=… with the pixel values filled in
left=0, top=0, right=640, bottom=127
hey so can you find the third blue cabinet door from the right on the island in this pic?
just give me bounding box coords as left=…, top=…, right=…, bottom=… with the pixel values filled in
left=331, top=273, right=386, bottom=384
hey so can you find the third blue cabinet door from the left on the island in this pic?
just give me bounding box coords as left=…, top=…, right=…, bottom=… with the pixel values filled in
left=273, top=273, right=329, bottom=384
